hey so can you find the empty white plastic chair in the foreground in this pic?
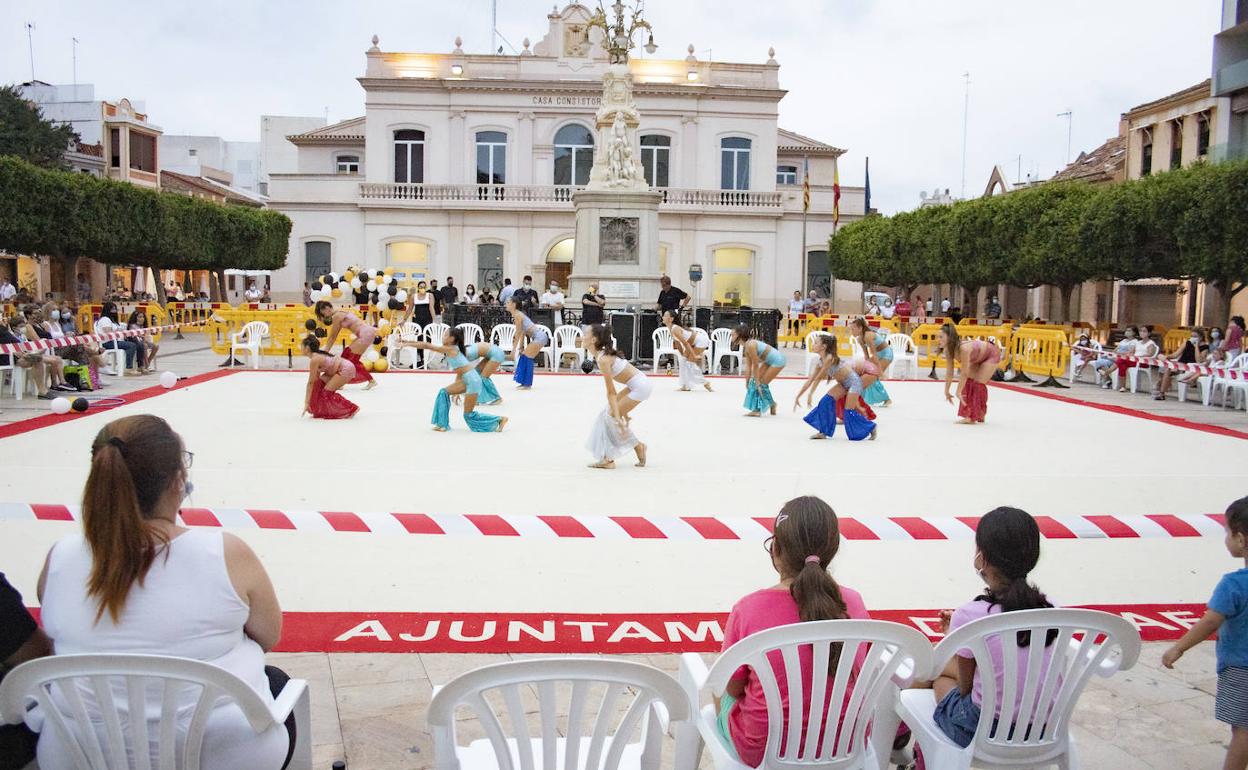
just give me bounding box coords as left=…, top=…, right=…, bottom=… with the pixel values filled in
left=427, top=656, right=694, bottom=770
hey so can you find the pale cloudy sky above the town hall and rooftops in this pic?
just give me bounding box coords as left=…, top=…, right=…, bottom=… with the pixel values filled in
left=0, top=0, right=1221, bottom=213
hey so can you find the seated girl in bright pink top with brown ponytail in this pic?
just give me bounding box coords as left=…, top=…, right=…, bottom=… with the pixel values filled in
left=715, top=497, right=870, bottom=768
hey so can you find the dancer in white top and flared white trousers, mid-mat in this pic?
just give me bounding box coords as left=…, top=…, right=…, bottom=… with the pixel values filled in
left=582, top=324, right=654, bottom=468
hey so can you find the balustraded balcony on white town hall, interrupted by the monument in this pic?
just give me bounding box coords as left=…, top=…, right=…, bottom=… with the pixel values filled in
left=359, top=182, right=784, bottom=216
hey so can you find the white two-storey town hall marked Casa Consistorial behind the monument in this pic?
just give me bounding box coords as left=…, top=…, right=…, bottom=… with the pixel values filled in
left=270, top=4, right=864, bottom=307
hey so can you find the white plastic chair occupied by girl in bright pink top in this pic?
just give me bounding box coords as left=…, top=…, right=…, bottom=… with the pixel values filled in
left=680, top=620, right=932, bottom=770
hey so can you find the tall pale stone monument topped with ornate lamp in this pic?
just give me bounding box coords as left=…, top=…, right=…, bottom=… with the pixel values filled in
left=568, top=1, right=663, bottom=306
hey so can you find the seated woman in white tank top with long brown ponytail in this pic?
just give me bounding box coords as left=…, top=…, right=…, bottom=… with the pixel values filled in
left=39, top=414, right=295, bottom=770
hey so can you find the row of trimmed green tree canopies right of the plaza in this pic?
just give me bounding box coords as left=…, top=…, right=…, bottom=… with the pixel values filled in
left=827, top=161, right=1248, bottom=318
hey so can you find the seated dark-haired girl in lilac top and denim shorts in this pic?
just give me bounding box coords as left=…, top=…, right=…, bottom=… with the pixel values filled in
left=931, top=508, right=1053, bottom=748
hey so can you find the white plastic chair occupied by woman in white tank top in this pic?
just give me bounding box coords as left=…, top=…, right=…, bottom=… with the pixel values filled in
left=0, top=654, right=312, bottom=770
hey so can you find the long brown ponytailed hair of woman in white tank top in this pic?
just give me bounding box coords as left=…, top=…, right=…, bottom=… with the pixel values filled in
left=82, top=414, right=185, bottom=623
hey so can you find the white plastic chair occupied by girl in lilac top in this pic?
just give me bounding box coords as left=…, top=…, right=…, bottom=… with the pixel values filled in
left=897, top=609, right=1139, bottom=770
